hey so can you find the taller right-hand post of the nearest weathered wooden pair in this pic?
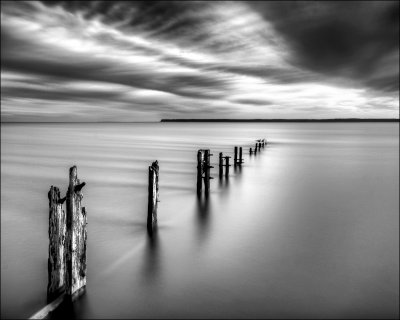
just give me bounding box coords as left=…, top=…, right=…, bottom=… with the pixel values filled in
left=65, top=166, right=87, bottom=298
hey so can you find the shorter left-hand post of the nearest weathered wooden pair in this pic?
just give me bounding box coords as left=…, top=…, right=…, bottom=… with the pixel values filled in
left=47, top=186, right=66, bottom=302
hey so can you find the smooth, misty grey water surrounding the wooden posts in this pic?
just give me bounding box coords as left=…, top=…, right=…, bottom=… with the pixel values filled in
left=1, top=123, right=399, bottom=318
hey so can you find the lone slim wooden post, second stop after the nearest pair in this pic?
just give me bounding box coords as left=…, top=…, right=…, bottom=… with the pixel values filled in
left=147, top=160, right=159, bottom=232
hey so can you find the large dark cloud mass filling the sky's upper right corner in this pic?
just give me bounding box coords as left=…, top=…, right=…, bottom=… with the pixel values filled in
left=249, top=1, right=399, bottom=91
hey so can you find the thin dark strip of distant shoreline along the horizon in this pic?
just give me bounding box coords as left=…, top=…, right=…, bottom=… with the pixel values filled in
left=160, top=118, right=399, bottom=122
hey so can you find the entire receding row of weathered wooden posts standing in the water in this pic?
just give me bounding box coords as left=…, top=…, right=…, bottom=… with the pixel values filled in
left=43, top=139, right=266, bottom=316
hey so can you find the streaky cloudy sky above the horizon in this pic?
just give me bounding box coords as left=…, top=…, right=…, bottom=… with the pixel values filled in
left=1, top=1, right=399, bottom=122
